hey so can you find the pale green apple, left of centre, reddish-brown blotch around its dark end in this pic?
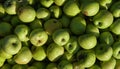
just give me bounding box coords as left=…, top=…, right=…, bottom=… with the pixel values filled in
left=29, top=28, right=48, bottom=47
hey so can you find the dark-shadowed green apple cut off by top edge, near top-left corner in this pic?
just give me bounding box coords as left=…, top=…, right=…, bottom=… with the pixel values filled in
left=4, top=0, right=17, bottom=15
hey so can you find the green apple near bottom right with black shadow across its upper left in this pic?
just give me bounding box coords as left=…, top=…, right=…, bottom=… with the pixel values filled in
left=77, top=50, right=96, bottom=68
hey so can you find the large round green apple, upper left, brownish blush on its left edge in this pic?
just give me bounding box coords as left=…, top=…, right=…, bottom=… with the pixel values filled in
left=17, top=6, right=36, bottom=23
